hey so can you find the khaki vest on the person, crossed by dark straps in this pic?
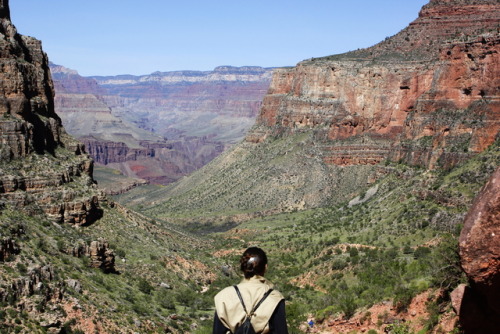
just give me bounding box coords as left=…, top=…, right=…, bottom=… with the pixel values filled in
left=214, top=275, right=284, bottom=333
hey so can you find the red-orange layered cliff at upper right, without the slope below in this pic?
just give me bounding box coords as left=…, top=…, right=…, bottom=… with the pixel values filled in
left=254, top=0, right=500, bottom=168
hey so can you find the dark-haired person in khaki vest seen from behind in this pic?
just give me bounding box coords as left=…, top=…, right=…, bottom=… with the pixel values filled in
left=213, top=247, right=288, bottom=334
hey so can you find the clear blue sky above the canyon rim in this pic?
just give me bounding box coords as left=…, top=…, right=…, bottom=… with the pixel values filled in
left=10, top=0, right=428, bottom=76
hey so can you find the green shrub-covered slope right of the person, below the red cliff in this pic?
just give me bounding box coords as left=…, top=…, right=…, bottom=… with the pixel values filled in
left=193, top=143, right=500, bottom=332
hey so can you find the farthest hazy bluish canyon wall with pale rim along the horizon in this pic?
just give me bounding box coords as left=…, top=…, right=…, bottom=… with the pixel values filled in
left=93, top=66, right=272, bottom=144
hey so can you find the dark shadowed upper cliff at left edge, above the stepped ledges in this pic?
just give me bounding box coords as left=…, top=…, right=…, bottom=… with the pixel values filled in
left=0, top=0, right=61, bottom=160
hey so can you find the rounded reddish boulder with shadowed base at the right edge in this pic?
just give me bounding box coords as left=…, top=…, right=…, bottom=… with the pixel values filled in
left=452, top=168, right=500, bottom=333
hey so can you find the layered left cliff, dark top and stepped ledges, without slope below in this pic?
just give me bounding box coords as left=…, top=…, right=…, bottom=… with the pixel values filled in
left=0, top=0, right=100, bottom=224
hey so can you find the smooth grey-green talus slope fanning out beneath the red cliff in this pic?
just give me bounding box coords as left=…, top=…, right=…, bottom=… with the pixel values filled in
left=117, top=134, right=374, bottom=223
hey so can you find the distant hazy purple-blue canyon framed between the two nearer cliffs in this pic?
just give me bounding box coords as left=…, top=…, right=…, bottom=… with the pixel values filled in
left=51, top=64, right=271, bottom=185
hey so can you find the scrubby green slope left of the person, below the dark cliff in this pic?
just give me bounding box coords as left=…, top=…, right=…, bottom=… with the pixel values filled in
left=0, top=196, right=220, bottom=333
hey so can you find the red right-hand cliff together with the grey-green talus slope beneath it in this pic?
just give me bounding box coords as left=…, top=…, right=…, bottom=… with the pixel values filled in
left=124, top=0, right=500, bottom=224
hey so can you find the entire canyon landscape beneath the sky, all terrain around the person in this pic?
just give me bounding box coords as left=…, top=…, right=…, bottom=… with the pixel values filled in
left=0, top=0, right=500, bottom=334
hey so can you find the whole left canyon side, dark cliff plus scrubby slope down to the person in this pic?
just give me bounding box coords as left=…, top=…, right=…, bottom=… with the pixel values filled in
left=0, top=0, right=221, bottom=334
